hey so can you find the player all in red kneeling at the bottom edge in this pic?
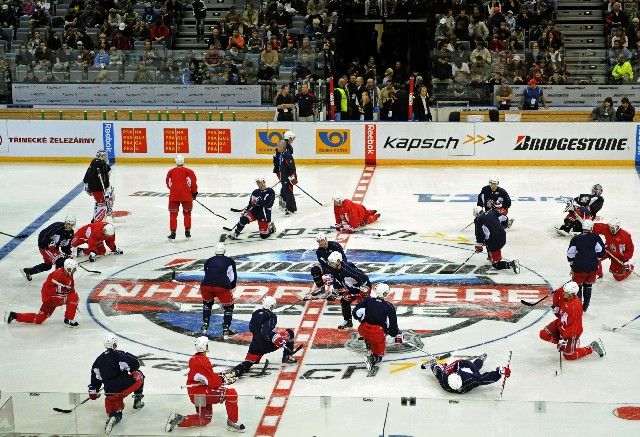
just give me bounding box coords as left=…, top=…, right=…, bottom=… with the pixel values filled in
left=165, top=337, right=244, bottom=432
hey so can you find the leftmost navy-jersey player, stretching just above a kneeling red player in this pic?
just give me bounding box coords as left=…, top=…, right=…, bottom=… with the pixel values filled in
left=21, top=215, right=76, bottom=281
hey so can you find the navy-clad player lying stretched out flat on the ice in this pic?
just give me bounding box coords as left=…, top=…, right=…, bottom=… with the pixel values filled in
left=420, top=354, right=511, bottom=394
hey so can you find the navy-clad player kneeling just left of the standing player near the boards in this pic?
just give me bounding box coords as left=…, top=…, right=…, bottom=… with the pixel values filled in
left=227, top=176, right=276, bottom=240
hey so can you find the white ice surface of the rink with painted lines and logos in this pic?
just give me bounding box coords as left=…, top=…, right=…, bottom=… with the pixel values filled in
left=0, top=159, right=640, bottom=437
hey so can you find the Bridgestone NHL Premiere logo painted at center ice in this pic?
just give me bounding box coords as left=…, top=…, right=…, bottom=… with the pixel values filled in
left=88, top=246, right=549, bottom=353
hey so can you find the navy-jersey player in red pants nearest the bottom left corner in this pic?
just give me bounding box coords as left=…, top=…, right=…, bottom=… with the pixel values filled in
left=89, top=333, right=144, bottom=434
